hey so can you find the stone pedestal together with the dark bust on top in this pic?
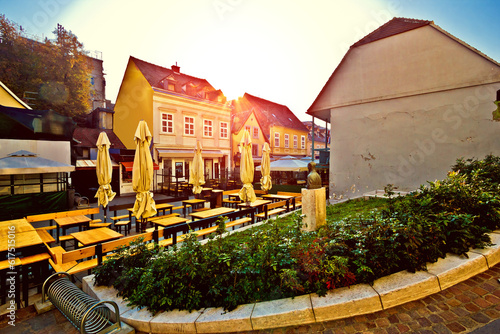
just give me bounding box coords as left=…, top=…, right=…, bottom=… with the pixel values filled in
left=302, top=161, right=326, bottom=231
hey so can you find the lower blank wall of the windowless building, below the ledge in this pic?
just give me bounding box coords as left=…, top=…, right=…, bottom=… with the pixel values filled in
left=330, top=83, right=500, bottom=197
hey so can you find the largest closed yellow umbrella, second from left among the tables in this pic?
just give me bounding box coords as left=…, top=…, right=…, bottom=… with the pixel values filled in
left=132, top=121, right=156, bottom=231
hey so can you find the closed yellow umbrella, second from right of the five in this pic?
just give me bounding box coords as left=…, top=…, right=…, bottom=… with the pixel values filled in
left=239, top=130, right=256, bottom=202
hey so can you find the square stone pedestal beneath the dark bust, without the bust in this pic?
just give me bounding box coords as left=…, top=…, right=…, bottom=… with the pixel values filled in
left=302, top=187, right=326, bottom=231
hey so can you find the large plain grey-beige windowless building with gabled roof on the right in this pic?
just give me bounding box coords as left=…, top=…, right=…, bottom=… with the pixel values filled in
left=307, top=18, right=500, bottom=197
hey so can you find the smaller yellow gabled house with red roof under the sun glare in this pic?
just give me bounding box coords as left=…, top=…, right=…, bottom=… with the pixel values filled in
left=232, top=93, right=308, bottom=165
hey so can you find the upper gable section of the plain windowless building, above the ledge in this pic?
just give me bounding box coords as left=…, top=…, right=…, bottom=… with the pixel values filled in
left=311, top=26, right=500, bottom=111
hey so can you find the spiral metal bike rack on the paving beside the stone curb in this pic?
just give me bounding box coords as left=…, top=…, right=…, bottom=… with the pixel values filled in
left=42, top=272, right=121, bottom=334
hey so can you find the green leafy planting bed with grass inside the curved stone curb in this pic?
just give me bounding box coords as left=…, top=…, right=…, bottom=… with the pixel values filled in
left=96, top=157, right=500, bottom=313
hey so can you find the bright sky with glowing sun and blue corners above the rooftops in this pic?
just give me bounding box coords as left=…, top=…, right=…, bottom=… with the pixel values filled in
left=0, top=0, right=500, bottom=121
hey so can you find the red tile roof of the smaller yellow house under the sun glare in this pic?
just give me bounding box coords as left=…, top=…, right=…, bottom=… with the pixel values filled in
left=231, top=93, right=308, bottom=139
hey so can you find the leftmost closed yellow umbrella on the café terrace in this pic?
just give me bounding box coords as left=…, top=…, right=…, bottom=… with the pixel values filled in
left=94, top=132, right=116, bottom=222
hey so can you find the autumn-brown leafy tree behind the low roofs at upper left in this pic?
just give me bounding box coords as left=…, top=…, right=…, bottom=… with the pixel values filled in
left=0, top=15, right=92, bottom=120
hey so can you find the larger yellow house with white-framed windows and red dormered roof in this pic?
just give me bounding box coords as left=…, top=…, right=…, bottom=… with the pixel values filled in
left=114, top=57, right=231, bottom=189
